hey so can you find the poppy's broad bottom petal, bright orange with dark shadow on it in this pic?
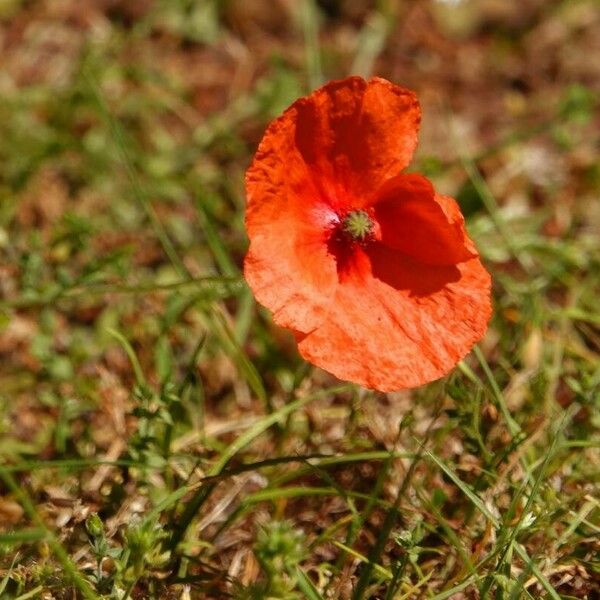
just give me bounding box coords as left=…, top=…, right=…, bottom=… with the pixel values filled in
left=297, top=245, right=491, bottom=391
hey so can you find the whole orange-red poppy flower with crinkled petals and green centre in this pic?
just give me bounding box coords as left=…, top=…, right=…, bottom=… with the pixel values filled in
left=244, top=77, right=491, bottom=391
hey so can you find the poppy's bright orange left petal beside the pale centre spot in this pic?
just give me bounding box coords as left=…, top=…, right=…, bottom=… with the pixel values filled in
left=244, top=89, right=337, bottom=331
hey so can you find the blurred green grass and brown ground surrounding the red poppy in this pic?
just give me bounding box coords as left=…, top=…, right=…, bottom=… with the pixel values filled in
left=0, top=0, right=600, bottom=600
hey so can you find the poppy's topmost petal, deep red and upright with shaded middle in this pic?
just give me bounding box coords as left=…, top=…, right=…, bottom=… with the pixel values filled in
left=289, top=77, right=421, bottom=206
